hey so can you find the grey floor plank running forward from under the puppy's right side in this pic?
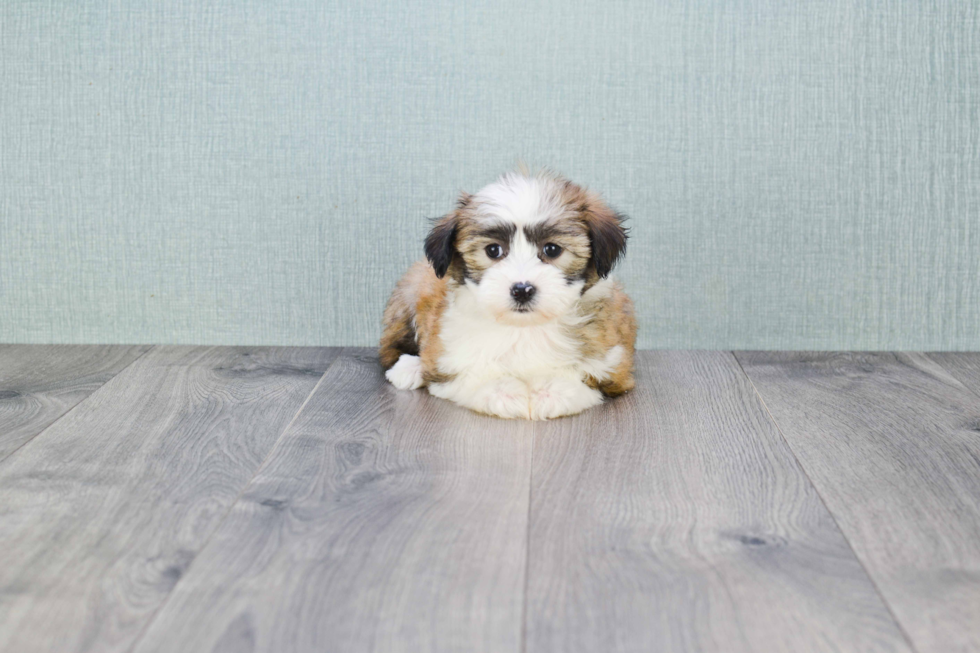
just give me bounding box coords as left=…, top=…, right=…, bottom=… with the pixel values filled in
left=527, top=352, right=909, bottom=653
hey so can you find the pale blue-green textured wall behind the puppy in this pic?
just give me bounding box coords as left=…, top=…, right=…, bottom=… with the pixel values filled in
left=0, top=0, right=980, bottom=349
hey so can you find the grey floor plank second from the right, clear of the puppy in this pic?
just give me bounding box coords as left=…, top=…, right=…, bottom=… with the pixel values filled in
left=738, top=352, right=980, bottom=653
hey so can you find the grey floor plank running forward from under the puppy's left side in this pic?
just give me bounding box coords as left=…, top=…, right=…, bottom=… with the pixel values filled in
left=130, top=350, right=532, bottom=653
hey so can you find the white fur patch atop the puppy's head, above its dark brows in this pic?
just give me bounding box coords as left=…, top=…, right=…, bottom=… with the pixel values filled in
left=474, top=174, right=559, bottom=227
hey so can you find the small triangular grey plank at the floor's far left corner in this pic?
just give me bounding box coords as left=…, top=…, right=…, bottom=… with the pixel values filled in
left=0, top=345, right=150, bottom=460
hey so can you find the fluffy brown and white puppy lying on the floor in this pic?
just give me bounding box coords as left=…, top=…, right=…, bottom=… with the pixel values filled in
left=380, top=171, right=636, bottom=419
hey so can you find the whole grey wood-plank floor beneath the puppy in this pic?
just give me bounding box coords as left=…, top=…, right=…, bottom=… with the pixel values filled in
left=0, top=345, right=980, bottom=653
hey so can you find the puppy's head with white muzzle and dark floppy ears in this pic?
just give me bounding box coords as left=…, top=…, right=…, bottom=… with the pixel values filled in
left=425, top=173, right=627, bottom=325
